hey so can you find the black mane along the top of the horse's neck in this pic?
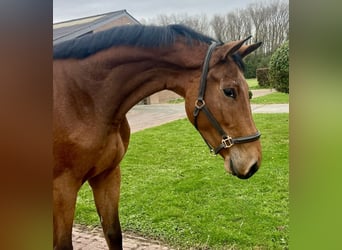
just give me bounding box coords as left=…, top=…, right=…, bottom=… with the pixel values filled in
left=53, top=24, right=215, bottom=59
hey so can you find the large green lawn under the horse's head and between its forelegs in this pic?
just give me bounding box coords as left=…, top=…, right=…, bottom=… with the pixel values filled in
left=76, top=114, right=289, bottom=249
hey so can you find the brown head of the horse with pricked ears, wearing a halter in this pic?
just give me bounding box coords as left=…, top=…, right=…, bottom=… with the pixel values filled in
left=185, top=37, right=261, bottom=179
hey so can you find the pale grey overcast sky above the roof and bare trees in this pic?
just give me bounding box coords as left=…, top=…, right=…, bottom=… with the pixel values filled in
left=53, top=0, right=262, bottom=23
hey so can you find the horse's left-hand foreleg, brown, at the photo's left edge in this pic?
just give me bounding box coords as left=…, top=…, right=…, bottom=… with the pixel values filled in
left=53, top=174, right=80, bottom=250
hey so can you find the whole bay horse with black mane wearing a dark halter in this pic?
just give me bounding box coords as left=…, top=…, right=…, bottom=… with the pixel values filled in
left=53, top=25, right=261, bottom=249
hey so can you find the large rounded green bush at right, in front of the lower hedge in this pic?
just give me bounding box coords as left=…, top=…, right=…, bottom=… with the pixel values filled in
left=269, top=41, right=289, bottom=93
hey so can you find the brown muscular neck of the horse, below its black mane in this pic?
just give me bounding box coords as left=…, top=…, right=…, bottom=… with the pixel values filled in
left=76, top=44, right=208, bottom=123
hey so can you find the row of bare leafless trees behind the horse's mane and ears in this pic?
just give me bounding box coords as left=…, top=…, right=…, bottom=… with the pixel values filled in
left=143, top=0, right=289, bottom=54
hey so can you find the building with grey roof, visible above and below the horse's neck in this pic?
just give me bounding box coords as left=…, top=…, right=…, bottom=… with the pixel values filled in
left=53, top=10, right=180, bottom=104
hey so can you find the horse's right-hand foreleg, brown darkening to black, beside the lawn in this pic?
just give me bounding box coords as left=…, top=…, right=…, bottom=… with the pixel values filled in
left=89, top=166, right=122, bottom=250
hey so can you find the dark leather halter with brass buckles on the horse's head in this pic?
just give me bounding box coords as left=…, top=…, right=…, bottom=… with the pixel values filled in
left=194, top=42, right=261, bottom=155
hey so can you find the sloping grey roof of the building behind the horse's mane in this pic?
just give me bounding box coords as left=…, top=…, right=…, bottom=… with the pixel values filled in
left=53, top=10, right=140, bottom=45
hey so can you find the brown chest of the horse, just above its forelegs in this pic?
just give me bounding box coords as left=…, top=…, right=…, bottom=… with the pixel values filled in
left=55, top=127, right=125, bottom=179
